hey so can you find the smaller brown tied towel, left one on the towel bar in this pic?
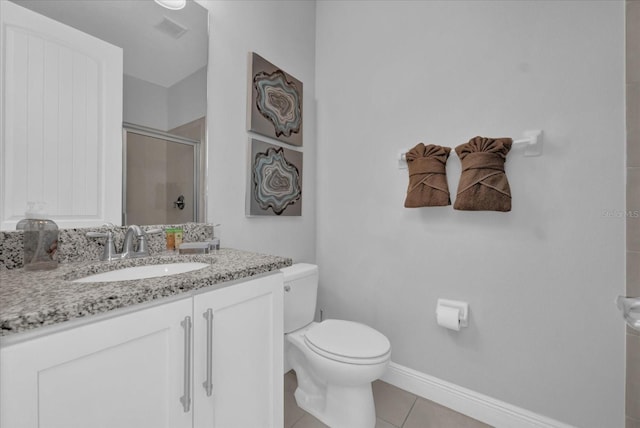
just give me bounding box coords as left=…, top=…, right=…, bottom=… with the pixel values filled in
left=404, top=143, right=451, bottom=208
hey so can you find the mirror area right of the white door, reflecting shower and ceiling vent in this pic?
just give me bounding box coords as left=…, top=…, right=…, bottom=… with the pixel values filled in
left=12, top=0, right=209, bottom=225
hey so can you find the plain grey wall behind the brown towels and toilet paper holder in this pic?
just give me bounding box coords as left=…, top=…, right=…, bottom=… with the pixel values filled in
left=316, top=1, right=625, bottom=427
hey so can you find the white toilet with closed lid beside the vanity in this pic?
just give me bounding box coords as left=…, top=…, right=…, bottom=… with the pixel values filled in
left=281, top=263, right=391, bottom=428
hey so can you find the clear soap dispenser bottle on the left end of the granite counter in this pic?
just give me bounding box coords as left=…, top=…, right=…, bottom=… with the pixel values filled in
left=16, top=203, right=58, bottom=271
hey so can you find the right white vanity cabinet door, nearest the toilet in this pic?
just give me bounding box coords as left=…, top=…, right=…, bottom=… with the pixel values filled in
left=193, top=273, right=284, bottom=428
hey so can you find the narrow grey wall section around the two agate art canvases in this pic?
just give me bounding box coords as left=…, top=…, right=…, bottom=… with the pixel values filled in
left=199, top=0, right=316, bottom=262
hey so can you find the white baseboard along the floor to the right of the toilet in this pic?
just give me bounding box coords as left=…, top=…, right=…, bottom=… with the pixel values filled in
left=382, top=362, right=573, bottom=428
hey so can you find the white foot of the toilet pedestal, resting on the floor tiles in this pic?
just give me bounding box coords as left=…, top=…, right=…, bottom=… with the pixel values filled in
left=294, top=383, right=376, bottom=428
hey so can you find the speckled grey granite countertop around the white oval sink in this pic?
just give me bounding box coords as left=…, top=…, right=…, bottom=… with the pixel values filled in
left=0, top=249, right=292, bottom=336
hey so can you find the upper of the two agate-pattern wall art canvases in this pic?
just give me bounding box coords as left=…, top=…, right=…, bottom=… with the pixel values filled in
left=247, top=52, right=302, bottom=146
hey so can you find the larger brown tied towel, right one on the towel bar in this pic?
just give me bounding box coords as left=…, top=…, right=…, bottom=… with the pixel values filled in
left=453, top=137, right=513, bottom=211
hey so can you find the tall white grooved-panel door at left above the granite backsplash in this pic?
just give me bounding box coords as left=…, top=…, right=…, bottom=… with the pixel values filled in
left=0, top=1, right=123, bottom=230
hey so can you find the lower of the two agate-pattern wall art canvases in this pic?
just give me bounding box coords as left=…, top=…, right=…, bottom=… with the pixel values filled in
left=246, top=138, right=302, bottom=216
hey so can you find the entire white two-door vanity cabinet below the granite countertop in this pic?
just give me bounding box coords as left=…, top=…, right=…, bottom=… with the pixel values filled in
left=0, top=274, right=283, bottom=428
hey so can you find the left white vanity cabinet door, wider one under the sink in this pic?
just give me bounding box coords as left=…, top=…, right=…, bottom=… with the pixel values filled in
left=0, top=298, right=193, bottom=428
